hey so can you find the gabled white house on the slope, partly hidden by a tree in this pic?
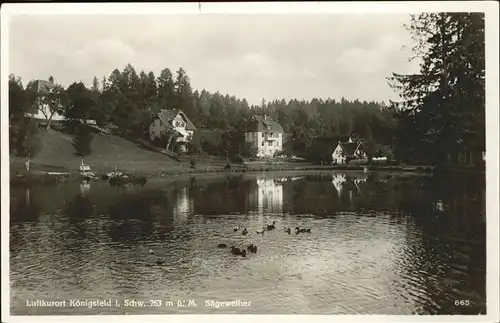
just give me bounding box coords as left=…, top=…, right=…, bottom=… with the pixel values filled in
left=149, top=109, right=196, bottom=151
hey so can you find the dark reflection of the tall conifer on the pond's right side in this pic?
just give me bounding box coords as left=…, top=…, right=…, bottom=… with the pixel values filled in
left=398, top=174, right=486, bottom=314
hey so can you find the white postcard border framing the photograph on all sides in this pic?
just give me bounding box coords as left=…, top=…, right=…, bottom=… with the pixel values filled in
left=0, top=1, right=500, bottom=322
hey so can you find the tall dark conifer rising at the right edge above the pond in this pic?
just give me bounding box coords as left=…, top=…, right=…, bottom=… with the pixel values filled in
left=390, top=13, right=485, bottom=164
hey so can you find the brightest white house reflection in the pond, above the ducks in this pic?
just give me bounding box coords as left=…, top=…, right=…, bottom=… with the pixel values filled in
left=257, top=179, right=283, bottom=212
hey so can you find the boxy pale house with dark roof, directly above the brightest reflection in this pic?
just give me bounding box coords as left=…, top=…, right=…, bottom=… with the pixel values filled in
left=245, top=115, right=283, bottom=158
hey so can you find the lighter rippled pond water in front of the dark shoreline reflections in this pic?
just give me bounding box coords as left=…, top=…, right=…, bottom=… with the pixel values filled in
left=10, top=175, right=485, bottom=314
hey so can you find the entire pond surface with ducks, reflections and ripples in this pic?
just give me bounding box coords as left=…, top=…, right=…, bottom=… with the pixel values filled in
left=10, top=172, right=486, bottom=315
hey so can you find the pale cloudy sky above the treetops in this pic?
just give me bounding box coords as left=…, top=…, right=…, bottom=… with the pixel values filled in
left=9, top=13, right=418, bottom=104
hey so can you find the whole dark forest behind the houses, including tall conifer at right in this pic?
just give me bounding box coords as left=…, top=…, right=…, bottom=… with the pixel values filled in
left=9, top=13, right=485, bottom=164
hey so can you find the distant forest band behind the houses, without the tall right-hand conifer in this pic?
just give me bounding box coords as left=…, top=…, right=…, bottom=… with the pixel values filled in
left=5, top=64, right=394, bottom=161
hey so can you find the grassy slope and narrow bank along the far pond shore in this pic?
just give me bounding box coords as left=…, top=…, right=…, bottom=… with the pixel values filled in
left=10, top=130, right=440, bottom=182
